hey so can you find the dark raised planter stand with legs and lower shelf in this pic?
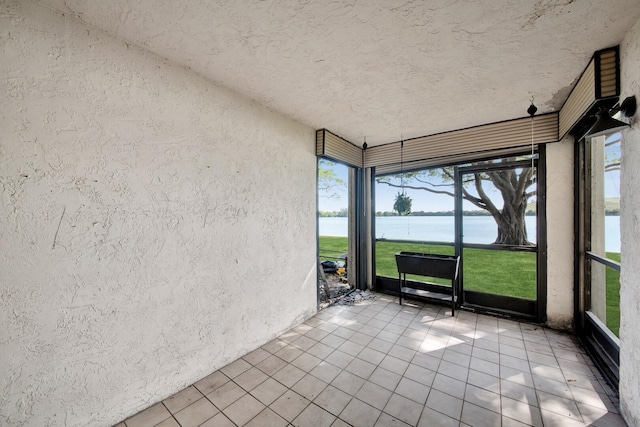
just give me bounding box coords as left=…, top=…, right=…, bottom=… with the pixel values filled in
left=396, top=252, right=460, bottom=316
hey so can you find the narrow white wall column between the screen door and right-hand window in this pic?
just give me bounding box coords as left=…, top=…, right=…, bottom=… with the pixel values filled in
left=547, top=137, right=574, bottom=329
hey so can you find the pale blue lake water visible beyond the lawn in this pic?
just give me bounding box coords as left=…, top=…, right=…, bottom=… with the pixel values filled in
left=319, top=216, right=620, bottom=252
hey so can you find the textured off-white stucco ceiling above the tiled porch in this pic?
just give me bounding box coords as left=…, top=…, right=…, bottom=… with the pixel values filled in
left=41, top=0, right=640, bottom=146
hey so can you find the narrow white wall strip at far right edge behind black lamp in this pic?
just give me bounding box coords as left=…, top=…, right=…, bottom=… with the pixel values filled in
left=620, top=15, right=640, bottom=426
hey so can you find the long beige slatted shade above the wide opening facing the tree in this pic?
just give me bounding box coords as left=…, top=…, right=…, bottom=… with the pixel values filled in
left=365, top=113, right=558, bottom=174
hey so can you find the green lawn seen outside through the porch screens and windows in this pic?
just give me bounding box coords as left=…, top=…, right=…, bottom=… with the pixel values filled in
left=320, top=236, right=620, bottom=336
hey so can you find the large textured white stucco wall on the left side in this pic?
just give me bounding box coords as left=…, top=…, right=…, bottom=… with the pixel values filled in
left=0, top=0, right=316, bottom=426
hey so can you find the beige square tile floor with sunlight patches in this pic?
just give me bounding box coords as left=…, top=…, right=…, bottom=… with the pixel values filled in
left=117, top=294, right=626, bottom=427
